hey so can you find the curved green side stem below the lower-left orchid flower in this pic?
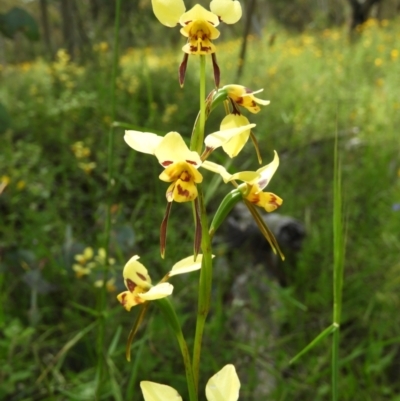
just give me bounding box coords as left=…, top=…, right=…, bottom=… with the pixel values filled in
left=155, top=298, right=197, bottom=401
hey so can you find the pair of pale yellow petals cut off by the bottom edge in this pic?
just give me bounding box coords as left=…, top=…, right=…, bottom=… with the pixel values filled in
left=140, top=365, right=240, bottom=401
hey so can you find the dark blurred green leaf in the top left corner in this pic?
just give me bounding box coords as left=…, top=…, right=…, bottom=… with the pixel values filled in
left=0, top=7, right=40, bottom=41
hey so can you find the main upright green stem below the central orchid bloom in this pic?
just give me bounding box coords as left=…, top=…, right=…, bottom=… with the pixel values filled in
left=193, top=185, right=212, bottom=388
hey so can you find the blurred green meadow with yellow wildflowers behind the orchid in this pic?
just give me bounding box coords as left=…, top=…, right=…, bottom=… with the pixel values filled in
left=0, top=0, right=400, bottom=401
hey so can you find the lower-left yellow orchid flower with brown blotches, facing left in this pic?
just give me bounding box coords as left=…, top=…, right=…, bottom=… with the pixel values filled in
left=117, top=255, right=202, bottom=311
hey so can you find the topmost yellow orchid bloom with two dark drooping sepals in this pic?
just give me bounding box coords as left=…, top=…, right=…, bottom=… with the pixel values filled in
left=151, top=0, right=242, bottom=87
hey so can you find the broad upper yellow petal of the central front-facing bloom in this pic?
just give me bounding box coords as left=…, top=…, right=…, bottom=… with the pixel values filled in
left=154, top=132, right=201, bottom=167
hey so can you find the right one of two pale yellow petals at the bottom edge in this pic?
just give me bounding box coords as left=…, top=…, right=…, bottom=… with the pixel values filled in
left=206, top=365, right=240, bottom=401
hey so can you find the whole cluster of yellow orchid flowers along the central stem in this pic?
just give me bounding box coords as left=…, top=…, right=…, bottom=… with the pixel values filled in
left=117, top=0, right=282, bottom=401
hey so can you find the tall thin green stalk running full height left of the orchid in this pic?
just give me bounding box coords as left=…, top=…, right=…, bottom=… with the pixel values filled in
left=96, top=0, right=122, bottom=399
